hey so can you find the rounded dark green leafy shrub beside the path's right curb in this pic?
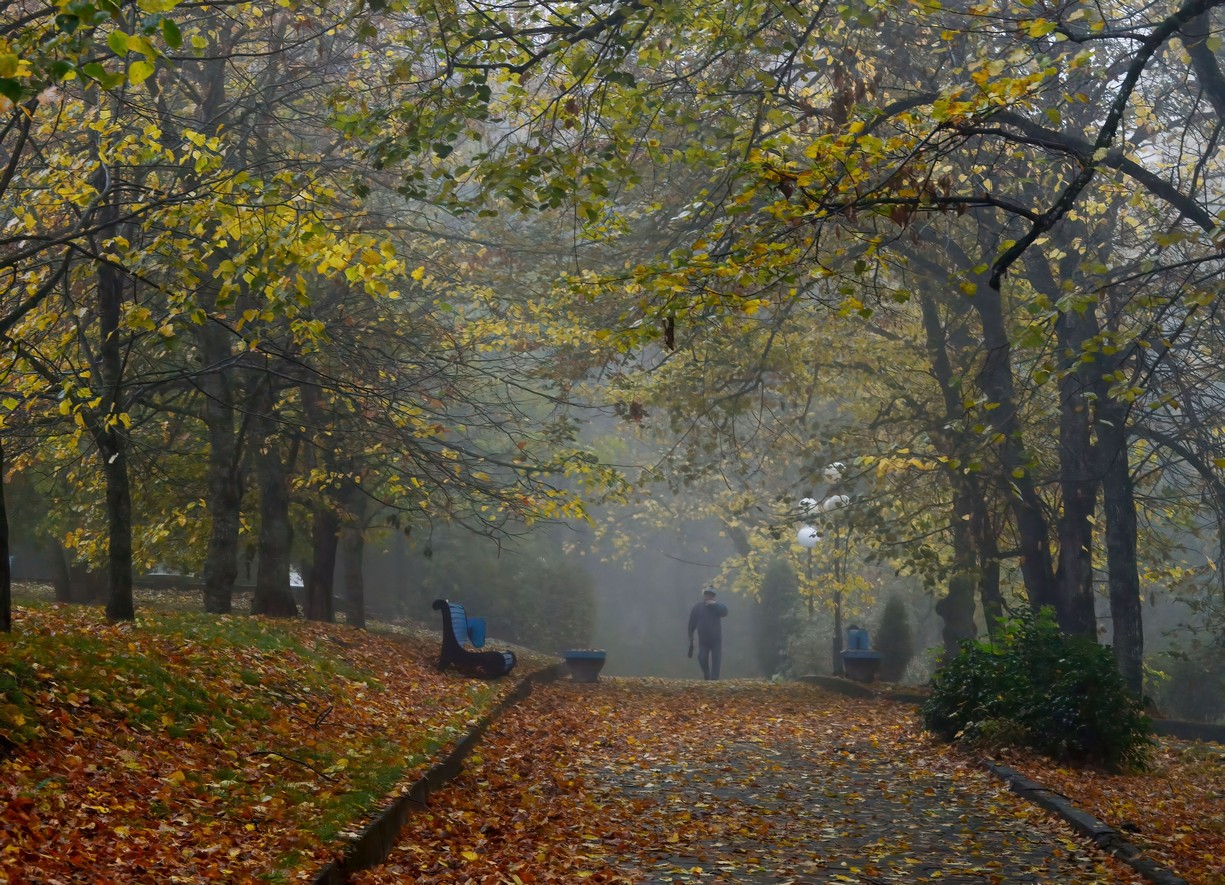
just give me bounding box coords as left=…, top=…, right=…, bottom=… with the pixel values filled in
left=921, top=612, right=1153, bottom=770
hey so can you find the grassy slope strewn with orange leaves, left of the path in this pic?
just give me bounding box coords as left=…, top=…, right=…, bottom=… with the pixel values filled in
left=0, top=585, right=552, bottom=883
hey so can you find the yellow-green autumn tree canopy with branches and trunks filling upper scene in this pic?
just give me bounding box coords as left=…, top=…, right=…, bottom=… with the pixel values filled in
left=0, top=0, right=1225, bottom=689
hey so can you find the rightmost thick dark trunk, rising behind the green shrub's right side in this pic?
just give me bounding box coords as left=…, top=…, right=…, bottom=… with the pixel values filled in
left=1098, top=399, right=1144, bottom=697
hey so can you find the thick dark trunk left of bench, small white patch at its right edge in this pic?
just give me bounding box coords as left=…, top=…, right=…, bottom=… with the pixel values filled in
left=251, top=378, right=298, bottom=618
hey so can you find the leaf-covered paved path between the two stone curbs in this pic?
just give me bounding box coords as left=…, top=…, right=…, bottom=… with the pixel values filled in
left=354, top=679, right=1140, bottom=885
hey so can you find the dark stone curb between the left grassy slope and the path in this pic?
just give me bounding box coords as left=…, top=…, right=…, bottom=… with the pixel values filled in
left=311, top=662, right=566, bottom=885
